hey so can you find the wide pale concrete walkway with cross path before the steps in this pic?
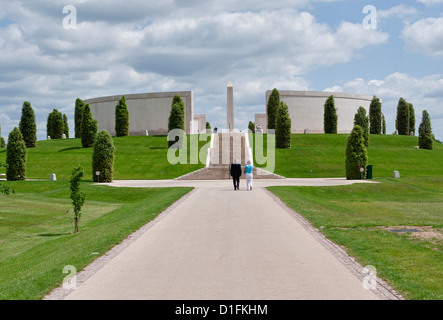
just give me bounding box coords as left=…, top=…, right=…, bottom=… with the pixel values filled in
left=47, top=179, right=400, bottom=300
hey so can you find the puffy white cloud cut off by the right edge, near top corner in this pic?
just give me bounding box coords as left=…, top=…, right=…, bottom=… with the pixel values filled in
left=402, top=17, right=443, bottom=57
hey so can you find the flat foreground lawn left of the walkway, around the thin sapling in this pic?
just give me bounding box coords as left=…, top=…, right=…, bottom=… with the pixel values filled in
left=0, top=181, right=192, bottom=300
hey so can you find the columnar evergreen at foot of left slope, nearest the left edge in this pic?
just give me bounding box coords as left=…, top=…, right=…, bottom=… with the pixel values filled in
left=6, top=128, right=28, bottom=181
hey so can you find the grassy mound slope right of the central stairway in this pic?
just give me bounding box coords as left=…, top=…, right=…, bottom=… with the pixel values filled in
left=250, top=134, right=443, bottom=178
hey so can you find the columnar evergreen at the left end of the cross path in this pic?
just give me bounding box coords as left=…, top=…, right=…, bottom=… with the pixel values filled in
left=92, top=130, right=115, bottom=182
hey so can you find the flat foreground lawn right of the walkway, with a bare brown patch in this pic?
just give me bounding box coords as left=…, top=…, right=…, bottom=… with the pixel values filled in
left=268, top=178, right=443, bottom=300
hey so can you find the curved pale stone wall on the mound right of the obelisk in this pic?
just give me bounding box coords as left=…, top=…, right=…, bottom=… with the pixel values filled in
left=266, top=90, right=373, bottom=133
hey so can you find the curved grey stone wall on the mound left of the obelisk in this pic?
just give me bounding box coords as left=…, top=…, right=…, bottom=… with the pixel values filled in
left=85, top=91, right=194, bottom=135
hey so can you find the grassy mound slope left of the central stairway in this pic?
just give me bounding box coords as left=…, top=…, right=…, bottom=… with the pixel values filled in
left=0, top=135, right=210, bottom=180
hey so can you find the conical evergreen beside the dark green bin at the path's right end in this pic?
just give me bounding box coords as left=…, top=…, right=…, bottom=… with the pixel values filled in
left=346, top=125, right=368, bottom=180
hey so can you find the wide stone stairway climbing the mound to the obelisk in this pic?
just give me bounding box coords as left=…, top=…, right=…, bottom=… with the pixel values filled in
left=176, top=133, right=284, bottom=180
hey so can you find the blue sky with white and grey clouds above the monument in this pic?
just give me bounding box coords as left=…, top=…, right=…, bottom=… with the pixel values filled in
left=0, top=0, right=443, bottom=140
